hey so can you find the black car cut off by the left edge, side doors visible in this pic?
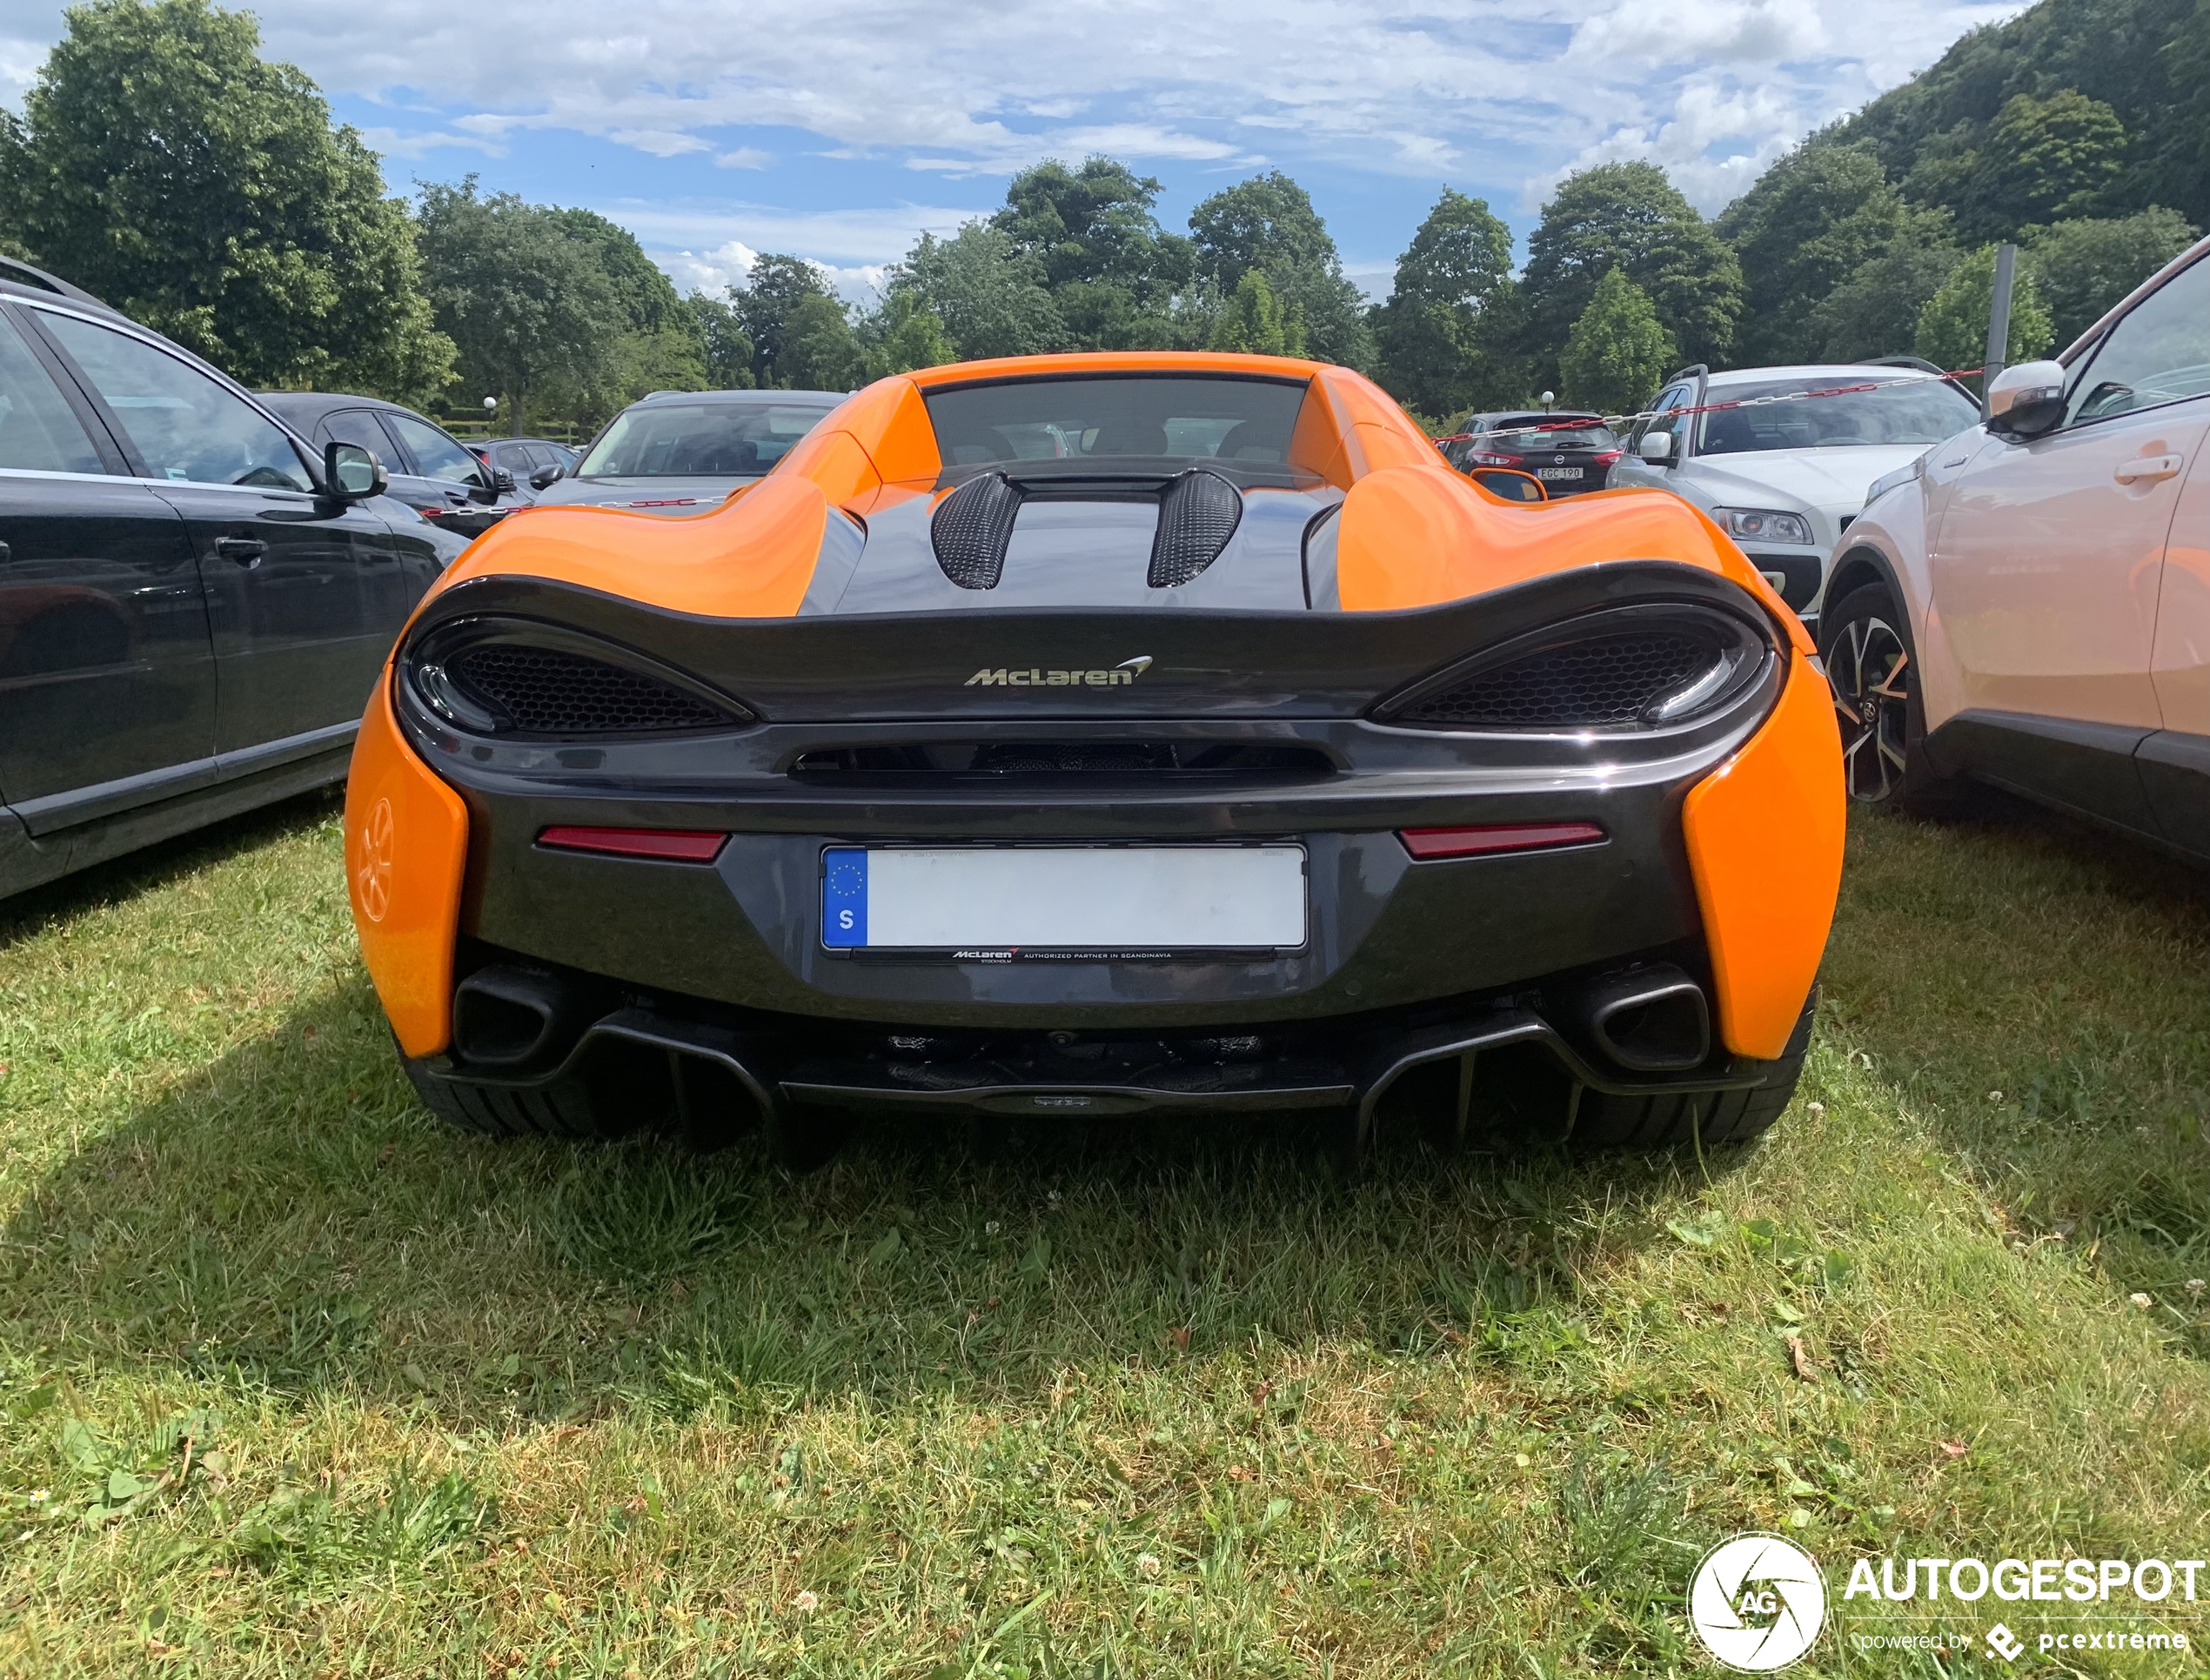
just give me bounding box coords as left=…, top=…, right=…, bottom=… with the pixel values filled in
left=0, top=263, right=464, bottom=895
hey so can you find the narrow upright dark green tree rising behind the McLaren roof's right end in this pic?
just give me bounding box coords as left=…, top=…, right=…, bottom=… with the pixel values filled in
left=1375, top=185, right=1511, bottom=416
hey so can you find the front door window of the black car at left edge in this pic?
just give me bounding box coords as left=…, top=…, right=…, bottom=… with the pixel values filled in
left=44, top=314, right=314, bottom=491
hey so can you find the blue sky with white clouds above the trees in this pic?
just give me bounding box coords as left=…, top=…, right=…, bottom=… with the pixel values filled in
left=0, top=0, right=2022, bottom=301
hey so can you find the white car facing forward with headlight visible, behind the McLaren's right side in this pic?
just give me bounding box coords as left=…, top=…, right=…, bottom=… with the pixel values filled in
left=1611, top=360, right=1980, bottom=624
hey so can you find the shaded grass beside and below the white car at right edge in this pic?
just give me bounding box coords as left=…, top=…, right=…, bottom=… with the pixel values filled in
left=1825, top=792, right=2210, bottom=1355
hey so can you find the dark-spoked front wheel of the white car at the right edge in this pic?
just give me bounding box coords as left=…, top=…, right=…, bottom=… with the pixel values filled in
left=1818, top=584, right=1949, bottom=811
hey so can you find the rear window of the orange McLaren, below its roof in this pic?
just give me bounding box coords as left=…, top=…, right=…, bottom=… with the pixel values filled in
left=924, top=373, right=1306, bottom=473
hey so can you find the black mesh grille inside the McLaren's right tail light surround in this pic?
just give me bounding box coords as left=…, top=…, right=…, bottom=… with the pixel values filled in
left=1395, top=630, right=1722, bottom=729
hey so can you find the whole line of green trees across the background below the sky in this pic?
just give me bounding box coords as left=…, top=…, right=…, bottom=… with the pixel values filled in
left=0, top=0, right=2210, bottom=431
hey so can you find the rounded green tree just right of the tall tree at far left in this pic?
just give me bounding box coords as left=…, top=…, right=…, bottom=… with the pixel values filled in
left=418, top=175, right=627, bottom=433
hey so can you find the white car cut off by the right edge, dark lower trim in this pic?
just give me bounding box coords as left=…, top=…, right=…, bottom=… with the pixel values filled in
left=1821, top=241, right=2210, bottom=858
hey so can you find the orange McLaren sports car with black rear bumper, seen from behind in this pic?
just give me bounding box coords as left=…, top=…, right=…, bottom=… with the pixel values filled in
left=347, top=354, right=1843, bottom=1165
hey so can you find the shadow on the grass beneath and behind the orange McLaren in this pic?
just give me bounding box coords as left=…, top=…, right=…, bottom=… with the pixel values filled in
left=0, top=980, right=1724, bottom=1426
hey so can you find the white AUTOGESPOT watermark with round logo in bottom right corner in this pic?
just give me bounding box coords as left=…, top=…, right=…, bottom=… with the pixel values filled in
left=1689, top=1534, right=2210, bottom=1673
